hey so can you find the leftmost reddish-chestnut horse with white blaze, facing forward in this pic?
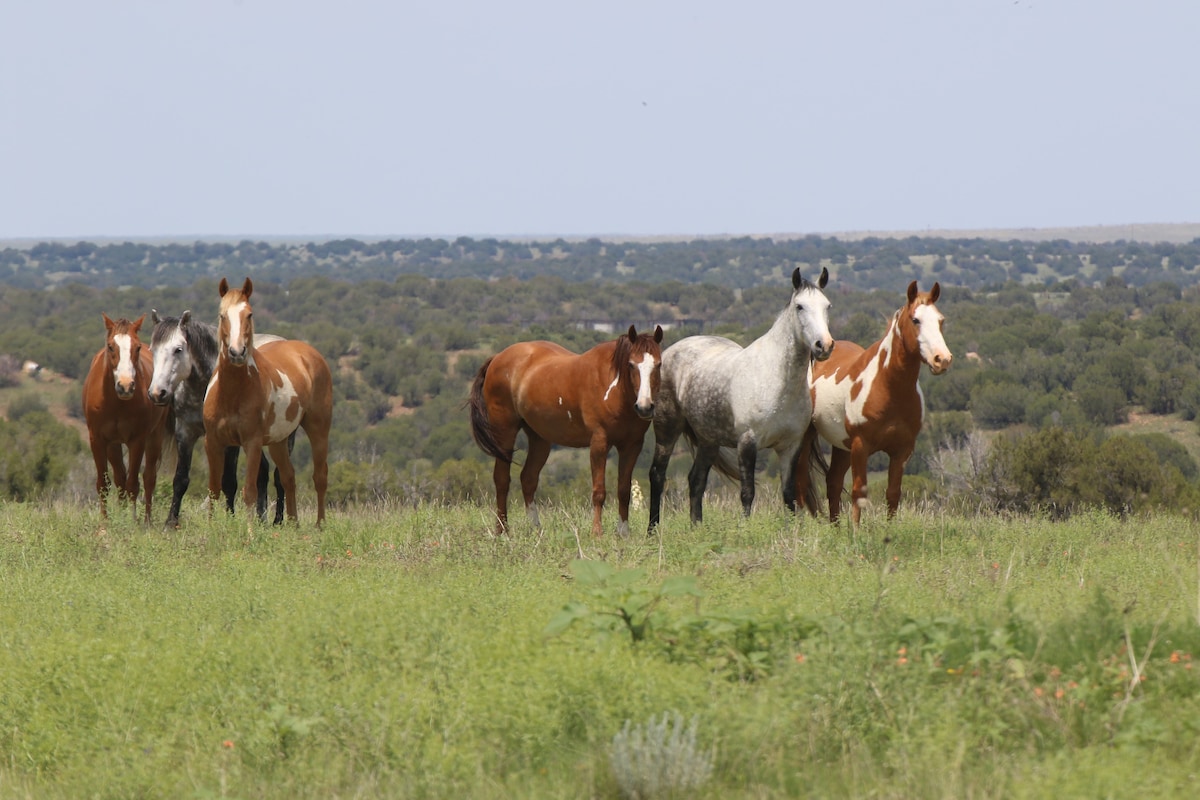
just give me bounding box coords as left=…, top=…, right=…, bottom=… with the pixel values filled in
left=83, top=314, right=174, bottom=524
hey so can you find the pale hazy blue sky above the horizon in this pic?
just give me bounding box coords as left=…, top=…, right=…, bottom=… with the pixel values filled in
left=0, top=0, right=1200, bottom=237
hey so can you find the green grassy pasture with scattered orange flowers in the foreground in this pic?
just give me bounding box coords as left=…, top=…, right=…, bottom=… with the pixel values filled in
left=0, top=496, right=1200, bottom=799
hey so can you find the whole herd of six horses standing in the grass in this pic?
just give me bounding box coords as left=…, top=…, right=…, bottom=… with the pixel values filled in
left=83, top=269, right=953, bottom=536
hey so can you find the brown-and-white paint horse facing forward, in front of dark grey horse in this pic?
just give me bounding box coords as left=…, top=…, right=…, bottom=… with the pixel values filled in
left=204, top=278, right=334, bottom=525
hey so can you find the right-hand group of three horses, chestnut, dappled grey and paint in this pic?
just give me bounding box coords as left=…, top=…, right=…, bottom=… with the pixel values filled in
left=468, top=269, right=953, bottom=534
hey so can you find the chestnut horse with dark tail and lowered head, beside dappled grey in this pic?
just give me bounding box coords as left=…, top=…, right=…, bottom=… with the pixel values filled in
left=467, top=325, right=662, bottom=536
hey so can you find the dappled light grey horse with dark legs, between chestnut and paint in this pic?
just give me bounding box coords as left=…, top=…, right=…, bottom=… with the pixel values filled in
left=649, top=269, right=834, bottom=533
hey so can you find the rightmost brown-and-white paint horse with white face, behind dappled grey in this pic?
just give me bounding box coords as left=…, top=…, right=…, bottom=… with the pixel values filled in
left=796, top=281, right=954, bottom=525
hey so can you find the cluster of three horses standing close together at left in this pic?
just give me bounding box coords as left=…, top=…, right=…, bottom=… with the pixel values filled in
left=83, top=278, right=334, bottom=529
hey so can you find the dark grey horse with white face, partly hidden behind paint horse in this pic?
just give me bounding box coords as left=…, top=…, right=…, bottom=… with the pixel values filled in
left=148, top=308, right=290, bottom=528
